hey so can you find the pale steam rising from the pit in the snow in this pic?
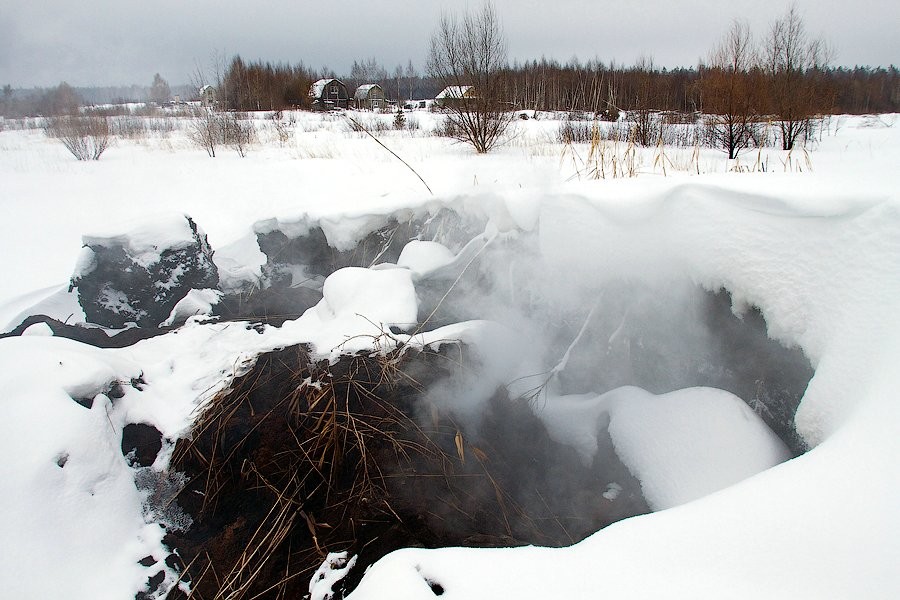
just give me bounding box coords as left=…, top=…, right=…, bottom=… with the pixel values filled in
left=404, top=200, right=812, bottom=507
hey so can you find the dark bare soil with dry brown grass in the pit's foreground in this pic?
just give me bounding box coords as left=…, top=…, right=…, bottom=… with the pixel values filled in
left=167, top=345, right=648, bottom=598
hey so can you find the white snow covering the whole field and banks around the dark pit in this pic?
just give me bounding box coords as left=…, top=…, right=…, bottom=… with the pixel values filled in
left=0, top=112, right=900, bottom=600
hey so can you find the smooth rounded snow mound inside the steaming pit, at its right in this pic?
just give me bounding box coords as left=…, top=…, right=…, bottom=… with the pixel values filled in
left=538, top=387, right=790, bottom=511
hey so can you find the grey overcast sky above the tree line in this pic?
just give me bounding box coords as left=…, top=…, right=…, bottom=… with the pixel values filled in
left=0, top=0, right=900, bottom=87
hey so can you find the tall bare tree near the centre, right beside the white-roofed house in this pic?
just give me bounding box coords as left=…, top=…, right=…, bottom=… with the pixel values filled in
left=428, top=3, right=513, bottom=153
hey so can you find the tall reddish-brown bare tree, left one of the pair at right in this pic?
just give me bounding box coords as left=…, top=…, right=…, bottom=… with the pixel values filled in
left=700, top=21, right=759, bottom=159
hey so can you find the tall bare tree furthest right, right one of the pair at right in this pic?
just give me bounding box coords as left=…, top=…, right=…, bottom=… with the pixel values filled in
left=766, top=5, right=830, bottom=150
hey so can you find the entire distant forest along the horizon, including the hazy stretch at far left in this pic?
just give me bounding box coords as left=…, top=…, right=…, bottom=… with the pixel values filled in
left=0, top=56, right=900, bottom=118
